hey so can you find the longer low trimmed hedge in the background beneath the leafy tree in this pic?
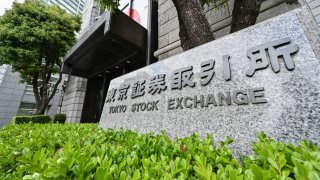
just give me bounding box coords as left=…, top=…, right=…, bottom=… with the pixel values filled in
left=12, top=115, right=52, bottom=124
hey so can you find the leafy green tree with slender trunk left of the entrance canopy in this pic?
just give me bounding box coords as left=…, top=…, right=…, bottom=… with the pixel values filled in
left=0, top=0, right=81, bottom=114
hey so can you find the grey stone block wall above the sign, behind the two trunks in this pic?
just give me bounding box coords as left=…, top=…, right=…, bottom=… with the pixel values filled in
left=155, top=0, right=302, bottom=60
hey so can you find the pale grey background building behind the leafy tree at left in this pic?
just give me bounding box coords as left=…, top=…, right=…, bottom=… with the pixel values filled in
left=0, top=0, right=84, bottom=128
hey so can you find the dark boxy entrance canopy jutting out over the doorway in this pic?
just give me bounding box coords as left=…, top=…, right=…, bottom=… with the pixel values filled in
left=62, top=10, right=147, bottom=78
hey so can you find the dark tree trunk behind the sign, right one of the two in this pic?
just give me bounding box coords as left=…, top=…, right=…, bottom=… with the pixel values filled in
left=230, top=0, right=263, bottom=33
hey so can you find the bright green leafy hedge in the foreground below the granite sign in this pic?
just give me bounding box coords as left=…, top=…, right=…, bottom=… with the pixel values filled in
left=0, top=124, right=320, bottom=180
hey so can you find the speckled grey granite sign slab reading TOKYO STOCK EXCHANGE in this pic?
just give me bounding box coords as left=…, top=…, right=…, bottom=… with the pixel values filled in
left=100, top=8, right=320, bottom=154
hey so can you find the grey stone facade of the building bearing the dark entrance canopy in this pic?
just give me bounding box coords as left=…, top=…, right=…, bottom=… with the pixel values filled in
left=62, top=0, right=320, bottom=122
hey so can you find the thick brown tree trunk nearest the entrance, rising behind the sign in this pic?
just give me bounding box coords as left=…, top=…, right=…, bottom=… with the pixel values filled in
left=172, top=0, right=214, bottom=51
